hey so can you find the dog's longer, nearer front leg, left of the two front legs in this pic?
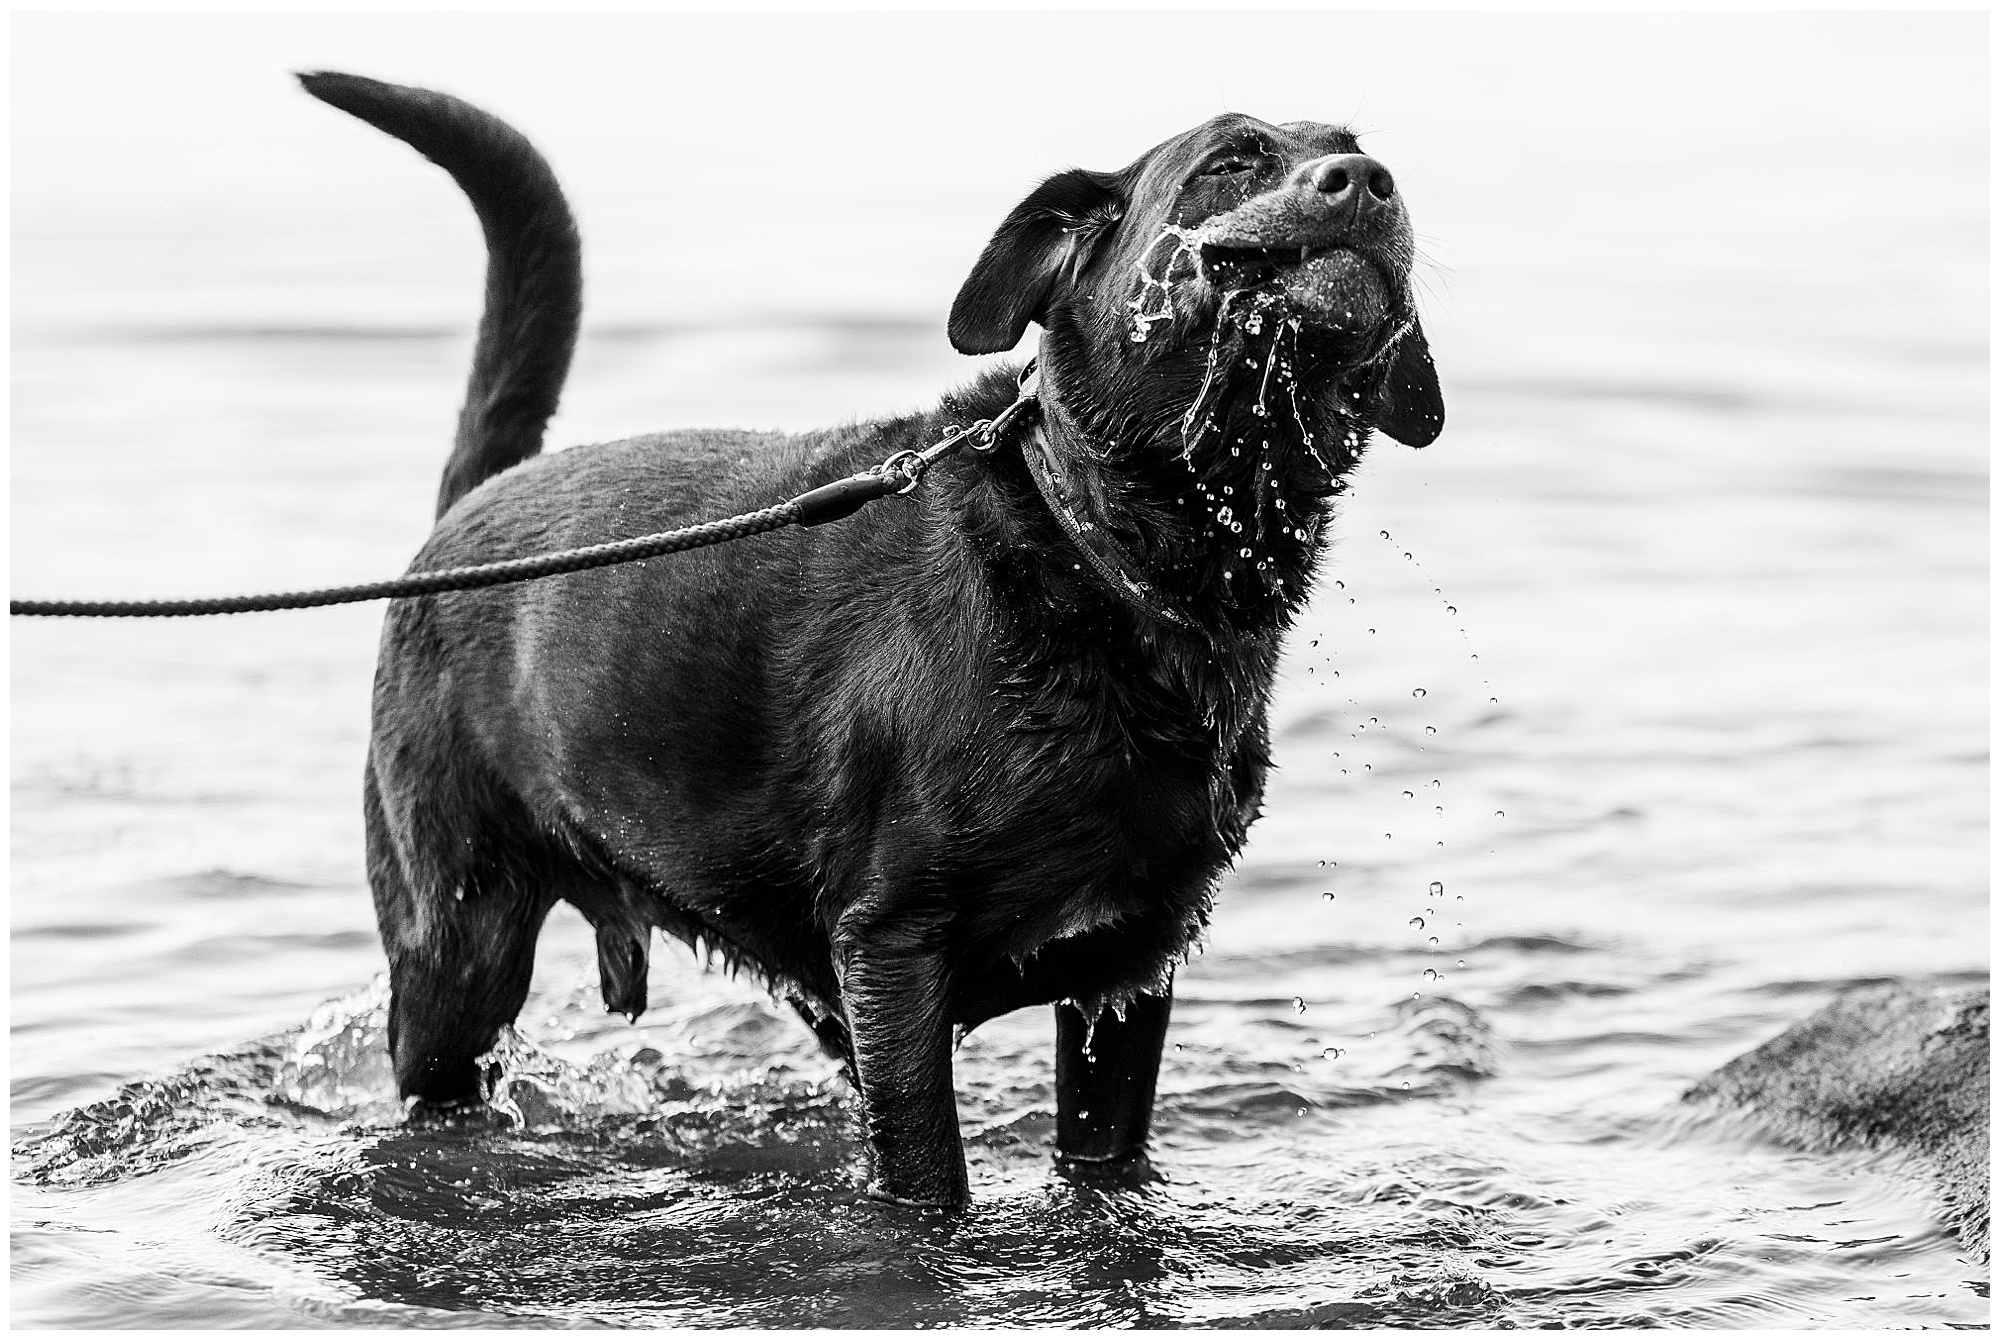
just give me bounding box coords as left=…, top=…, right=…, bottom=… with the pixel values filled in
left=838, top=918, right=966, bottom=1206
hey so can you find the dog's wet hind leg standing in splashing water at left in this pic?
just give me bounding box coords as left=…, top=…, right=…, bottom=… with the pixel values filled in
left=364, top=768, right=554, bottom=1108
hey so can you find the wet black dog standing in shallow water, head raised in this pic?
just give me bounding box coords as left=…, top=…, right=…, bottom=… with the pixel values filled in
left=304, top=74, right=1444, bottom=1204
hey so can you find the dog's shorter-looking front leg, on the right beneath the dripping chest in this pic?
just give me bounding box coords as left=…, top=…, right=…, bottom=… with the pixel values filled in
left=1056, top=984, right=1174, bottom=1164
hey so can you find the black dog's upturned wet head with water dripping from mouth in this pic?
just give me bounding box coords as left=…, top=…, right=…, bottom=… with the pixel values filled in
left=950, top=116, right=1444, bottom=476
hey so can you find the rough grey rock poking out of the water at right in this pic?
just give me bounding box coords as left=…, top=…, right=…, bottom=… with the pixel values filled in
left=1686, top=982, right=1992, bottom=1260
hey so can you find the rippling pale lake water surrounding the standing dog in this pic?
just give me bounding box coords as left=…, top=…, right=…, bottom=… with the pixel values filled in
left=10, top=12, right=1988, bottom=1328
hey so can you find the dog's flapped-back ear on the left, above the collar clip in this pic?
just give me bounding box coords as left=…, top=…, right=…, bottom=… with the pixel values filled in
left=946, top=168, right=1126, bottom=354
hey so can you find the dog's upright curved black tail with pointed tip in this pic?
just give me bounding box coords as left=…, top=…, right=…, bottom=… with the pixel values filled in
left=298, top=72, right=584, bottom=516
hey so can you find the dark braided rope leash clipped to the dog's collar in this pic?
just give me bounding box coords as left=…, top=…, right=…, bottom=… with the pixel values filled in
left=8, top=364, right=1034, bottom=618
